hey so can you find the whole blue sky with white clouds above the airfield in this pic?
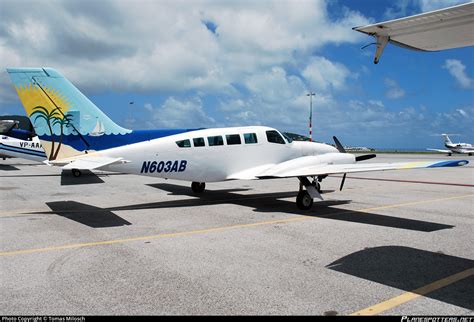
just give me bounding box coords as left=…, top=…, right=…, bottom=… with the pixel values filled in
left=0, top=0, right=474, bottom=149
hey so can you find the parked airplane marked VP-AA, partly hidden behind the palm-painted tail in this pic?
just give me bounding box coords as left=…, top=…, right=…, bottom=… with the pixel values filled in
left=0, top=120, right=47, bottom=162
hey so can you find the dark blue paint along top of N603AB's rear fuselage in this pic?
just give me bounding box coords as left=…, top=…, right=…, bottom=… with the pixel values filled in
left=40, top=129, right=204, bottom=151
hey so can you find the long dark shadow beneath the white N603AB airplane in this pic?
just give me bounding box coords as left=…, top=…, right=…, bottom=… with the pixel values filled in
left=40, top=183, right=454, bottom=232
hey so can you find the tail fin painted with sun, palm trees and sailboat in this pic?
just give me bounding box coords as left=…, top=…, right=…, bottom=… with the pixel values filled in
left=7, top=68, right=131, bottom=160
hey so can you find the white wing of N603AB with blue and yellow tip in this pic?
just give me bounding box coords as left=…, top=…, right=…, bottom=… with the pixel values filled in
left=257, top=160, right=469, bottom=179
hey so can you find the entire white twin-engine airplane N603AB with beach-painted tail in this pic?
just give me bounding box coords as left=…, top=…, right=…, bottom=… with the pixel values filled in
left=7, top=68, right=468, bottom=209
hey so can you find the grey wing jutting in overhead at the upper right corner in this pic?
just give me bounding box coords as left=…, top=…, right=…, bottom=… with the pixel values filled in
left=353, top=2, right=474, bottom=63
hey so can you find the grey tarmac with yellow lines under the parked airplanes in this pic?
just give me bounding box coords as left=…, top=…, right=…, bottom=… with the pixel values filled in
left=0, top=154, right=474, bottom=315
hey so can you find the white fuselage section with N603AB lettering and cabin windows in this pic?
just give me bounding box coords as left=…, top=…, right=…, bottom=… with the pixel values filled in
left=97, top=126, right=344, bottom=182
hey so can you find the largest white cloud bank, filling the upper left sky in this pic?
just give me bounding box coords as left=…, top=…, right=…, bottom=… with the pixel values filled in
left=0, top=0, right=368, bottom=100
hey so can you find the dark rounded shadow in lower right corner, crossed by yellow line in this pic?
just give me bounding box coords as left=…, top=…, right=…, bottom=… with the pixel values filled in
left=326, top=246, right=474, bottom=310
